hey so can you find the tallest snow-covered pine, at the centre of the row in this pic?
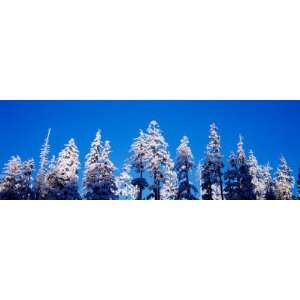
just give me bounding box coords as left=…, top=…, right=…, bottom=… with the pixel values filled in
left=147, top=121, right=172, bottom=200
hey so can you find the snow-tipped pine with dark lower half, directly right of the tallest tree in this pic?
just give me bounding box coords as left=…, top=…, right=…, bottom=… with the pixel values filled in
left=175, top=136, right=197, bottom=200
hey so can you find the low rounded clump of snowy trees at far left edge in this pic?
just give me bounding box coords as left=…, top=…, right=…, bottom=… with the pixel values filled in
left=0, top=156, right=34, bottom=200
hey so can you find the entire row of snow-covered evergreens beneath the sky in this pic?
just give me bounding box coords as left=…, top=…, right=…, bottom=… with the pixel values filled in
left=0, top=121, right=300, bottom=200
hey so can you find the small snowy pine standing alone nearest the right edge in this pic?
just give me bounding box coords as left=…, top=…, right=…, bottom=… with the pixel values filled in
left=275, top=156, right=294, bottom=200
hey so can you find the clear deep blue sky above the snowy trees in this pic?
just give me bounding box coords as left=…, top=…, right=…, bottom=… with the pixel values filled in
left=0, top=101, right=300, bottom=189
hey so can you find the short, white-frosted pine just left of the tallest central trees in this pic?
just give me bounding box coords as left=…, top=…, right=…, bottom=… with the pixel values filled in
left=116, top=163, right=139, bottom=200
